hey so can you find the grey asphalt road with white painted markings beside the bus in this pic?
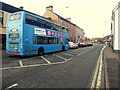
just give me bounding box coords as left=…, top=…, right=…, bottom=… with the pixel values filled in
left=2, top=45, right=103, bottom=89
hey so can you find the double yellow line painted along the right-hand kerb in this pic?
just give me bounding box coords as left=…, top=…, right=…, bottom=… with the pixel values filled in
left=91, top=46, right=106, bottom=89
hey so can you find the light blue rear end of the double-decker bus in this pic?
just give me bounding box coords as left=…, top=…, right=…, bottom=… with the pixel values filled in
left=6, top=12, right=23, bottom=55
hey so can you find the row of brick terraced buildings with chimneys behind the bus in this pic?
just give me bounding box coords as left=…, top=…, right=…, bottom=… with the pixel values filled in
left=43, top=6, right=85, bottom=42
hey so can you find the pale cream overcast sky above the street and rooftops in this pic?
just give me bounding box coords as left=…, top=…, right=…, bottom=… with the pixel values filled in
left=2, top=0, right=119, bottom=38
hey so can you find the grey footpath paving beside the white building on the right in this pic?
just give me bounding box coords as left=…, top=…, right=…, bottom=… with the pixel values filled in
left=104, top=47, right=120, bottom=89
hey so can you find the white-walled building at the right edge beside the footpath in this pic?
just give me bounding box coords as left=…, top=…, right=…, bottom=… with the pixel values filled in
left=111, top=2, right=120, bottom=52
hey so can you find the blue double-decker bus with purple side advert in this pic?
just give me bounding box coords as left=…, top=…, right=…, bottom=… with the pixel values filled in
left=6, top=11, right=69, bottom=56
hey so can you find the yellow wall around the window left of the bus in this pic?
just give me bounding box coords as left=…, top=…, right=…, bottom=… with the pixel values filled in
left=0, top=10, right=10, bottom=34
